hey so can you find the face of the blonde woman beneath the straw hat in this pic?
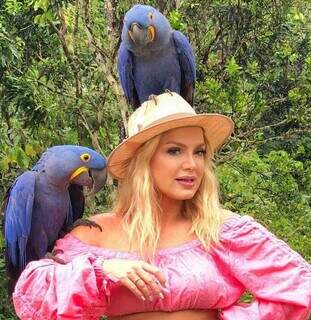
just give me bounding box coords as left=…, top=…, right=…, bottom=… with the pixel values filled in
left=150, top=127, right=206, bottom=200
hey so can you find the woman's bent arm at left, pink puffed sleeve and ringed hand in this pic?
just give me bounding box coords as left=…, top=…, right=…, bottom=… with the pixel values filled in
left=13, top=222, right=165, bottom=320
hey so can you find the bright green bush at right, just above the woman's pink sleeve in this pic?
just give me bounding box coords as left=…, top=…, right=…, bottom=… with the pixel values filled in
left=218, top=146, right=311, bottom=260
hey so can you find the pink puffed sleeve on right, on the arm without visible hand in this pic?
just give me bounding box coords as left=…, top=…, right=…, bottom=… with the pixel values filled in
left=218, top=216, right=311, bottom=320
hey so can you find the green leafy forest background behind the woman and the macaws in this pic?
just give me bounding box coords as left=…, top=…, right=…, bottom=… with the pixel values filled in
left=0, top=0, right=311, bottom=320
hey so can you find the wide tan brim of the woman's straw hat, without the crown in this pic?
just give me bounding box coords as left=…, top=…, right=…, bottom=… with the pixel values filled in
left=107, top=113, right=234, bottom=179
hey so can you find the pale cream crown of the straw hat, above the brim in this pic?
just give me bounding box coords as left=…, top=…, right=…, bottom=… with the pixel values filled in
left=128, top=92, right=196, bottom=137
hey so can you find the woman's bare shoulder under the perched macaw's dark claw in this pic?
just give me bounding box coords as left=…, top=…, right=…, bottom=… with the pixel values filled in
left=70, top=213, right=120, bottom=246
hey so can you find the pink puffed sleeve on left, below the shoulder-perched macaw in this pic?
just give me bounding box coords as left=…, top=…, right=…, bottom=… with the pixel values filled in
left=13, top=248, right=110, bottom=320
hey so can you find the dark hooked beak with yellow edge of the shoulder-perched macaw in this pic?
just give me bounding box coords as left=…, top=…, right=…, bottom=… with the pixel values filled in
left=70, top=167, right=107, bottom=196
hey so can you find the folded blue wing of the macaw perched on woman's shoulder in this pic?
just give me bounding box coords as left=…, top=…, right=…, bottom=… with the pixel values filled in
left=4, top=171, right=36, bottom=272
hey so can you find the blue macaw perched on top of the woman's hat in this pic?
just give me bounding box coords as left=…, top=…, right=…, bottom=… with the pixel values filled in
left=118, top=5, right=196, bottom=109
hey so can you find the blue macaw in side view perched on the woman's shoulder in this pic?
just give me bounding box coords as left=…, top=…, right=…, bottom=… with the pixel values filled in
left=4, top=145, right=107, bottom=291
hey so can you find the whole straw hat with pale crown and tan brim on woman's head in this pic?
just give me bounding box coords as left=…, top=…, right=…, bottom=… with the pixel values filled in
left=108, top=92, right=234, bottom=179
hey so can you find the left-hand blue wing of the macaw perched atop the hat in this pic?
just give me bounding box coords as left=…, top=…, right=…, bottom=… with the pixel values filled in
left=117, top=42, right=140, bottom=109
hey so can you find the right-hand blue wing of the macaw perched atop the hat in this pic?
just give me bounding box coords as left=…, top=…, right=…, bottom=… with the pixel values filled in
left=173, top=30, right=196, bottom=105
